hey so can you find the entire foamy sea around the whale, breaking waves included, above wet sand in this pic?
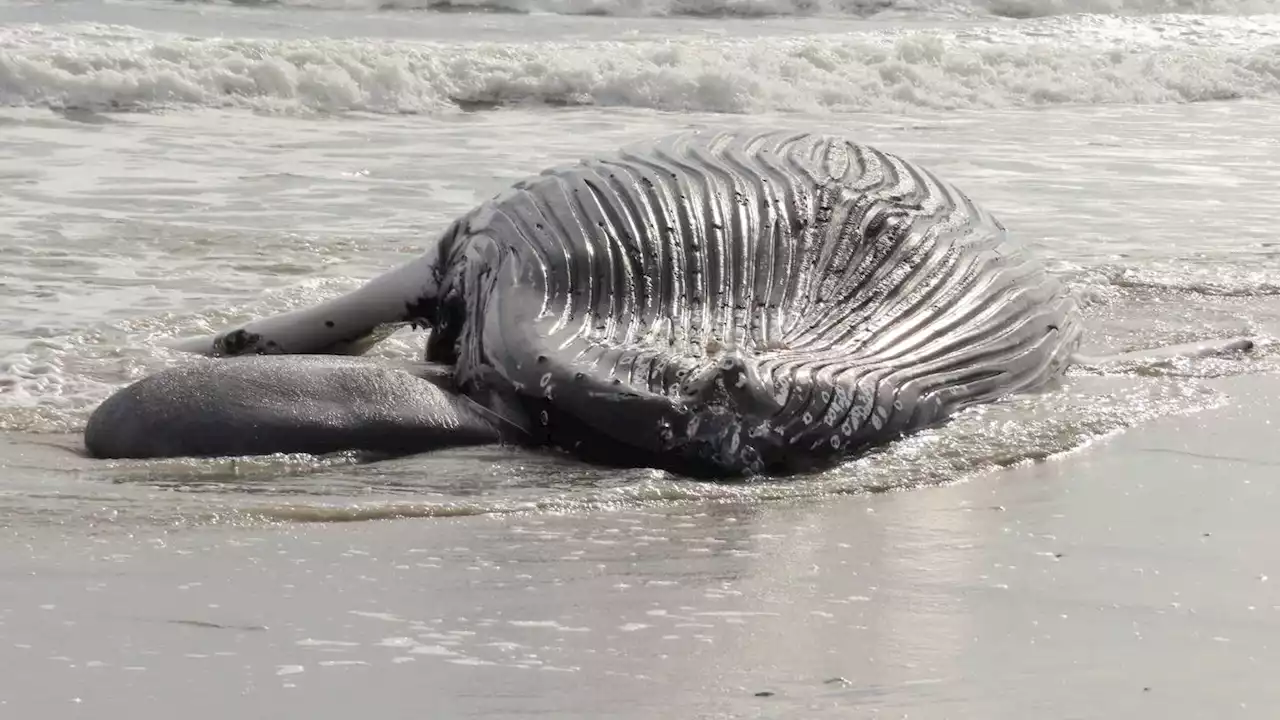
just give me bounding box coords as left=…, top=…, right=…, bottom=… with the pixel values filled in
left=0, top=0, right=1280, bottom=533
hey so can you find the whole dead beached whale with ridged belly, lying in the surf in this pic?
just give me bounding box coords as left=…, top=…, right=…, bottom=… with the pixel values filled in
left=84, top=131, right=1249, bottom=477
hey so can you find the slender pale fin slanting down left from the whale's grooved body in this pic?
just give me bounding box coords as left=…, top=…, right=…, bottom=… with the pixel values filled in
left=170, top=254, right=436, bottom=356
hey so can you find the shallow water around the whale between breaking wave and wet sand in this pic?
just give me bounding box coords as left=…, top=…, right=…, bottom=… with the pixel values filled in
left=0, top=102, right=1280, bottom=524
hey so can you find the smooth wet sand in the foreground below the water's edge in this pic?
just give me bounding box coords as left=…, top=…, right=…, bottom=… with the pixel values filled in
left=0, top=377, right=1280, bottom=720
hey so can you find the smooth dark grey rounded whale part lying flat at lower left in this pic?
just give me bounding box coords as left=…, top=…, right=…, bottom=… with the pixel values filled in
left=84, top=355, right=521, bottom=457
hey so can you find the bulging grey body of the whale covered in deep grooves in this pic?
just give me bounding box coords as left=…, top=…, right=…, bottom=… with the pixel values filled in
left=436, top=133, right=1079, bottom=474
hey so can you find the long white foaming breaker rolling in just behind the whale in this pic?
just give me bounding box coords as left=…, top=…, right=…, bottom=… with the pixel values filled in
left=0, top=18, right=1280, bottom=114
